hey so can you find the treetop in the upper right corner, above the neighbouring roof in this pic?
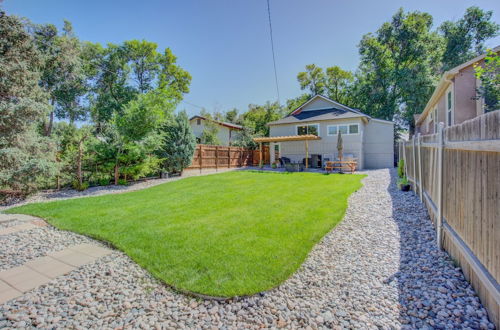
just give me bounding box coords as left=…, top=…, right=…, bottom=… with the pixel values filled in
left=439, top=6, right=500, bottom=71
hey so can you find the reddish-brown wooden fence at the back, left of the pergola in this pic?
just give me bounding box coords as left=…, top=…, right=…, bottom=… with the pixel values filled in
left=187, top=144, right=269, bottom=170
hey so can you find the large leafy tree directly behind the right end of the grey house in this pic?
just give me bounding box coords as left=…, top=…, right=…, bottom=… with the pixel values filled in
left=356, top=9, right=443, bottom=129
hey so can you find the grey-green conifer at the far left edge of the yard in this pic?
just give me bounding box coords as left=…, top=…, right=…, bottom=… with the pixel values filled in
left=0, top=11, right=55, bottom=191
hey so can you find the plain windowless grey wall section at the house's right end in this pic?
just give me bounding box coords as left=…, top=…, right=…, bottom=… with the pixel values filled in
left=363, top=119, right=394, bottom=168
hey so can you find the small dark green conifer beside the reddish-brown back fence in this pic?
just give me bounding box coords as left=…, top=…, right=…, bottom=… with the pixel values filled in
left=158, top=111, right=196, bottom=173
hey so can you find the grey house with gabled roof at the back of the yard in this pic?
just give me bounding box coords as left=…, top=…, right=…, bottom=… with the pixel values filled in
left=268, top=95, right=394, bottom=169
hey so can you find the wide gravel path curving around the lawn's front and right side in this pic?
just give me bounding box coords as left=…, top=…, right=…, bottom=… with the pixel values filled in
left=0, top=170, right=493, bottom=329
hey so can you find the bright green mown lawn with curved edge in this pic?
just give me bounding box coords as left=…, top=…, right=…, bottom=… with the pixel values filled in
left=8, top=171, right=364, bottom=297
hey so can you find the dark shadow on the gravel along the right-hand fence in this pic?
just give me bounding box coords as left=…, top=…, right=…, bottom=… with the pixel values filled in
left=384, top=169, right=488, bottom=329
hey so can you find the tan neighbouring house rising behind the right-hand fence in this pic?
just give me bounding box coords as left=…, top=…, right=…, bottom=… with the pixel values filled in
left=415, top=46, right=500, bottom=135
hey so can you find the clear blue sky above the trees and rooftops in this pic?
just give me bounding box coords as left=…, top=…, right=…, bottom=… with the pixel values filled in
left=3, top=0, right=500, bottom=114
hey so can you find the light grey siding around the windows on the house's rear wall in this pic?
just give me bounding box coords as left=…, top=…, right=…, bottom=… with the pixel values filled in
left=269, top=118, right=365, bottom=169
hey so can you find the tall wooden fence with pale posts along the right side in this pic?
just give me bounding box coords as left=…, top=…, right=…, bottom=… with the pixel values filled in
left=399, top=110, right=500, bottom=328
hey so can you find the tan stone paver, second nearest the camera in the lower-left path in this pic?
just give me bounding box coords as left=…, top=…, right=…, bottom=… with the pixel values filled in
left=0, top=266, right=50, bottom=292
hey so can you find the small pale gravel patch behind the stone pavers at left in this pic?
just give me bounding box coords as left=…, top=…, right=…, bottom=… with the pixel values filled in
left=0, top=226, right=93, bottom=270
